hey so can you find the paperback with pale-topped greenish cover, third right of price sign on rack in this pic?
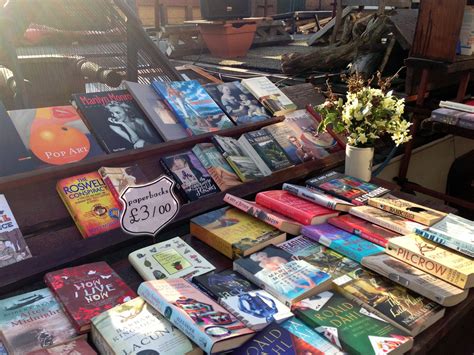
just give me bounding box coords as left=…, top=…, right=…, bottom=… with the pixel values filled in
left=212, top=136, right=263, bottom=182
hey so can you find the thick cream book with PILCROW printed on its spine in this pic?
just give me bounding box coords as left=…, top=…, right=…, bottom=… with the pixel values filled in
left=386, top=234, right=474, bottom=289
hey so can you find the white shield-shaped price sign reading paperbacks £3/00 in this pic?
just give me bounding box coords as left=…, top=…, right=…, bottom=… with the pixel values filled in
left=120, top=176, right=179, bottom=236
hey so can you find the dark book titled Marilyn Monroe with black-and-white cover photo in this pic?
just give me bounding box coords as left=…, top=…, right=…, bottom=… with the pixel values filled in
left=72, top=90, right=163, bottom=153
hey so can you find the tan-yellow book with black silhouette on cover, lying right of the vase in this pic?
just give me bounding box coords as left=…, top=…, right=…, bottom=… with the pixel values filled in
left=369, top=194, right=447, bottom=226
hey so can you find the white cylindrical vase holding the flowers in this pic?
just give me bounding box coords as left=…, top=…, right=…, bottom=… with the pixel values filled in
left=345, top=145, right=374, bottom=181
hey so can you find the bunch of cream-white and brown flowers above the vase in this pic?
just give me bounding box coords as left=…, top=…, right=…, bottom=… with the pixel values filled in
left=315, top=73, right=411, bottom=148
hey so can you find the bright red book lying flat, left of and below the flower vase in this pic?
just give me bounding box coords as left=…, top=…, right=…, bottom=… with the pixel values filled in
left=255, top=190, right=339, bottom=225
